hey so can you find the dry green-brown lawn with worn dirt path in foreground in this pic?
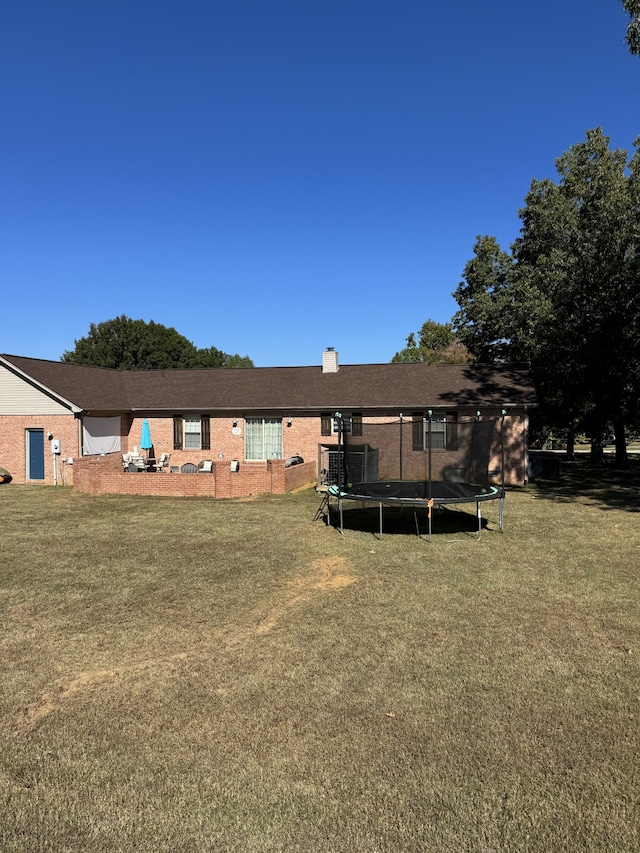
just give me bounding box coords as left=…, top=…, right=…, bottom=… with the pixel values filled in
left=0, top=466, right=640, bottom=853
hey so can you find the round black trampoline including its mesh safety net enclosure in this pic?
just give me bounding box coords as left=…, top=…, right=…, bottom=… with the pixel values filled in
left=325, top=411, right=505, bottom=542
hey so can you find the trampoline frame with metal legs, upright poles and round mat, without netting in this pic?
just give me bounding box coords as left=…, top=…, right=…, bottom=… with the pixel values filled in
left=318, top=409, right=506, bottom=542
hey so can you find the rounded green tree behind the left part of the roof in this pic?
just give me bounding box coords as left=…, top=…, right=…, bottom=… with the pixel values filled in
left=61, top=314, right=253, bottom=370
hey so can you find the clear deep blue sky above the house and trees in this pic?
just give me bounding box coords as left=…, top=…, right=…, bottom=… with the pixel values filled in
left=0, top=0, right=640, bottom=366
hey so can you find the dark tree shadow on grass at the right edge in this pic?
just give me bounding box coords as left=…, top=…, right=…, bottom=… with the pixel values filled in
left=534, top=459, right=640, bottom=512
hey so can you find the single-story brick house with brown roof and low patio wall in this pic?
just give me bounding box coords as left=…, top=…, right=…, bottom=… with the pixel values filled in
left=0, top=350, right=536, bottom=497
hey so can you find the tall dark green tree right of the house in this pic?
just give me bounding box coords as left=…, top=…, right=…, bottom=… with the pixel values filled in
left=453, top=128, right=640, bottom=462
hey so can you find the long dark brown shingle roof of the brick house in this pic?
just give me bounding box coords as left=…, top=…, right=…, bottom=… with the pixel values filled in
left=3, top=355, right=536, bottom=414
